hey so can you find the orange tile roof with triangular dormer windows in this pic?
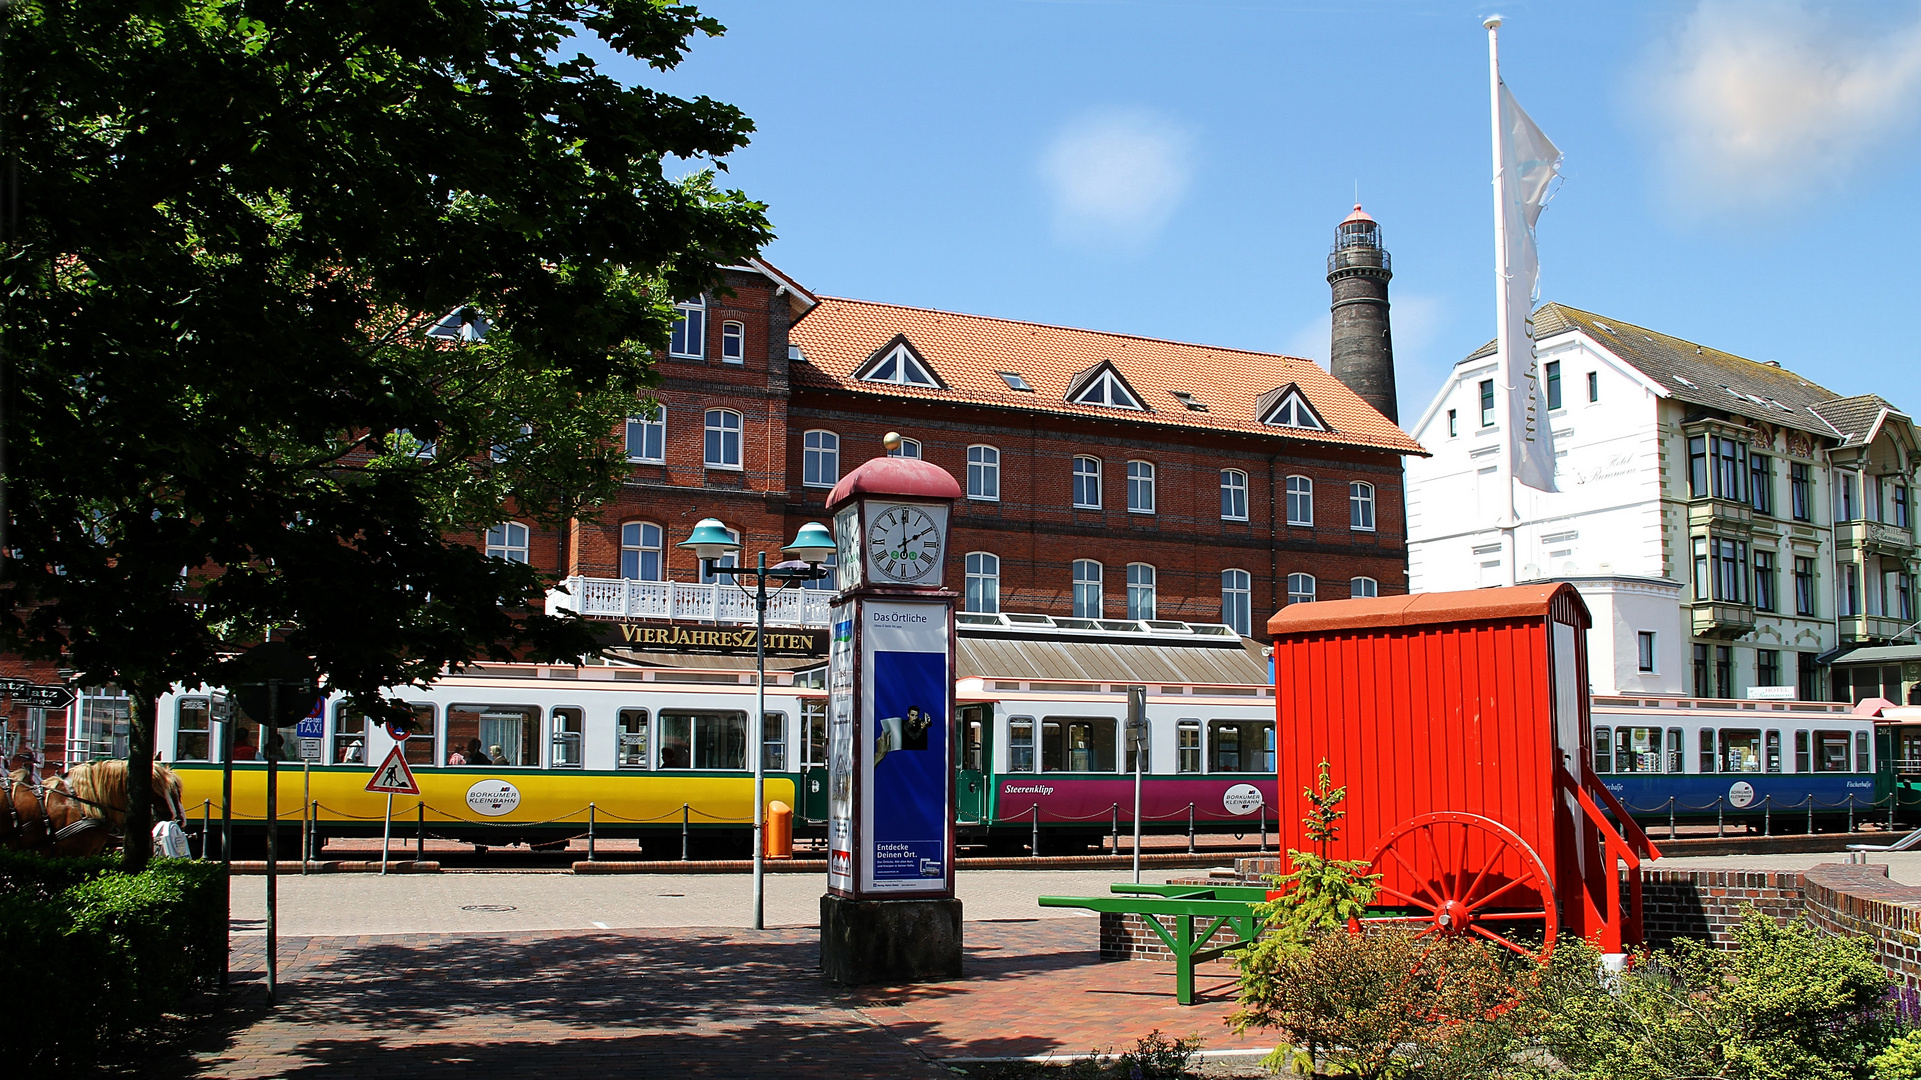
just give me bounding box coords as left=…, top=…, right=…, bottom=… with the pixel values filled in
left=790, top=296, right=1427, bottom=455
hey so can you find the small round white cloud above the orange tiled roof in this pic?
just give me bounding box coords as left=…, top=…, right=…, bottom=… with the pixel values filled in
left=1041, top=110, right=1193, bottom=246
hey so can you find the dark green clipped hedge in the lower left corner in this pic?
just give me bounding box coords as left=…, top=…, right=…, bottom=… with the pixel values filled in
left=0, top=855, right=227, bottom=1072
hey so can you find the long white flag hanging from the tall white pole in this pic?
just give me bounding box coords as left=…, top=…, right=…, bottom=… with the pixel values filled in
left=1496, top=83, right=1562, bottom=492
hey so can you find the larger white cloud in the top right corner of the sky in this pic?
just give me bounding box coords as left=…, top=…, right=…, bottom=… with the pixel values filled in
left=1644, top=0, right=1921, bottom=211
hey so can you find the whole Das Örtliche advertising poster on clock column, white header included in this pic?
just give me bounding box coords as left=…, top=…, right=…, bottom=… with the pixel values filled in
left=859, top=601, right=953, bottom=894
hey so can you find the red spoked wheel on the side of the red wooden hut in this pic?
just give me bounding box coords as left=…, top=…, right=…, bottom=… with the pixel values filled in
left=1362, top=811, right=1560, bottom=961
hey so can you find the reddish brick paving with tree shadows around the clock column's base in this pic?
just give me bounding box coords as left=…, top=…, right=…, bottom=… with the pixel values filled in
left=196, top=919, right=1272, bottom=1080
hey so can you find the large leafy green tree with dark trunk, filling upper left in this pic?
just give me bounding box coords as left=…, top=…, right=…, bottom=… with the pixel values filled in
left=0, top=0, right=770, bottom=869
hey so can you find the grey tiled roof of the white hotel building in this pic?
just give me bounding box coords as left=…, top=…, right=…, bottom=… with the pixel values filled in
left=1468, top=304, right=1840, bottom=438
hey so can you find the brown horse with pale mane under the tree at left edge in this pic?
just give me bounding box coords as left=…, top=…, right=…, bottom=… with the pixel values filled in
left=0, top=759, right=182, bottom=855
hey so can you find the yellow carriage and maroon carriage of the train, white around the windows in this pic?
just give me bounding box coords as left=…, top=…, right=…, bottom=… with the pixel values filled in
left=158, top=617, right=1274, bottom=859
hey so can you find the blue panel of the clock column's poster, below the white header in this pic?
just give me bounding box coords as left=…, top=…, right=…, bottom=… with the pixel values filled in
left=868, top=650, right=949, bottom=888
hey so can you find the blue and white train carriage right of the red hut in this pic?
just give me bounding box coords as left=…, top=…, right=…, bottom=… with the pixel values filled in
left=1593, top=696, right=1892, bottom=832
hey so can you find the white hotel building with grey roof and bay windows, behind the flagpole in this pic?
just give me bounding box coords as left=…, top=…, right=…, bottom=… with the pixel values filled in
left=1406, top=304, right=1921, bottom=701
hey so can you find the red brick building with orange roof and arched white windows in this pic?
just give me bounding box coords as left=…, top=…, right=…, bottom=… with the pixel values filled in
left=514, top=261, right=1422, bottom=636
